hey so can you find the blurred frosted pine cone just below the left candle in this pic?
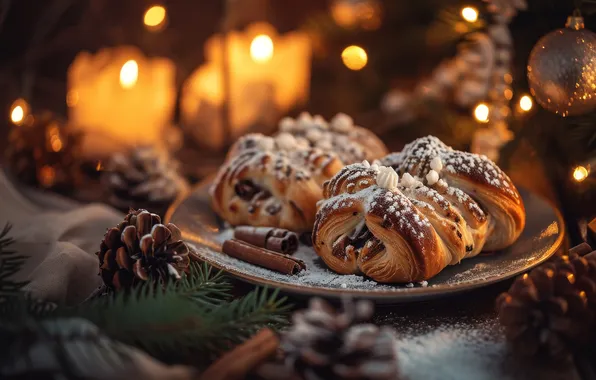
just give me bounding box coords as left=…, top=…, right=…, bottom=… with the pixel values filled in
left=103, top=147, right=188, bottom=213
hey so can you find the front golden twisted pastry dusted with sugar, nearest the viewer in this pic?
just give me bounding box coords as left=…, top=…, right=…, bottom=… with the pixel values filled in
left=313, top=162, right=488, bottom=282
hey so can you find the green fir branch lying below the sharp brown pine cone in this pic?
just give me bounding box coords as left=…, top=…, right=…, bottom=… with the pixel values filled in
left=53, top=265, right=287, bottom=362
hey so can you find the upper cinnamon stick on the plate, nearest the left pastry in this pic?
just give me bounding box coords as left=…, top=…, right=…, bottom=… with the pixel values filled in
left=234, top=226, right=298, bottom=254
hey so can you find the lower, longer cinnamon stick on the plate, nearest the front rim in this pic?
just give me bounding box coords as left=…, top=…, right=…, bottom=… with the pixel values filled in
left=221, top=239, right=306, bottom=274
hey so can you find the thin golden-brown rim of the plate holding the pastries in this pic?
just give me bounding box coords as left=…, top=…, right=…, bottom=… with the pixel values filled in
left=164, top=180, right=566, bottom=303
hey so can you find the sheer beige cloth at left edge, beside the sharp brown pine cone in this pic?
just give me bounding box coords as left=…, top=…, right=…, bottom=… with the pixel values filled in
left=0, top=170, right=124, bottom=305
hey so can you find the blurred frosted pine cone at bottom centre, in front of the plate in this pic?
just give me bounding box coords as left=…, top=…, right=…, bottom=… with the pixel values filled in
left=282, top=298, right=398, bottom=379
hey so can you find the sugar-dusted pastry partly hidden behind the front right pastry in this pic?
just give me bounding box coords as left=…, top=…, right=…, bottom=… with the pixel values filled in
left=381, top=136, right=526, bottom=251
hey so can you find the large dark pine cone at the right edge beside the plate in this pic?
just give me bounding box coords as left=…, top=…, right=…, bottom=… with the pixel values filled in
left=497, top=246, right=596, bottom=359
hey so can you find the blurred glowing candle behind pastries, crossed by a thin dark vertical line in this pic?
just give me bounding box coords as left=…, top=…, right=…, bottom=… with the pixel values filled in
left=180, top=23, right=311, bottom=149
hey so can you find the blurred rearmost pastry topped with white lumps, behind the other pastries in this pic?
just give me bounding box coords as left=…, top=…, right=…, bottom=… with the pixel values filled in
left=278, top=112, right=387, bottom=164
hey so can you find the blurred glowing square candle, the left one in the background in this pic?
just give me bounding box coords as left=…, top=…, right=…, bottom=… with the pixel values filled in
left=66, top=46, right=176, bottom=157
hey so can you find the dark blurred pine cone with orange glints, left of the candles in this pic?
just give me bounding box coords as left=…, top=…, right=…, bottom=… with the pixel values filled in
left=5, top=112, right=81, bottom=192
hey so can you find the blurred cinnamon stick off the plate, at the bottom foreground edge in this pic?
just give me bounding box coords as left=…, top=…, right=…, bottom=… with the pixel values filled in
left=201, top=328, right=279, bottom=380
